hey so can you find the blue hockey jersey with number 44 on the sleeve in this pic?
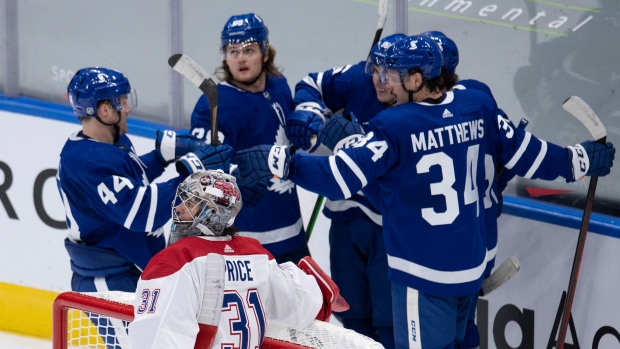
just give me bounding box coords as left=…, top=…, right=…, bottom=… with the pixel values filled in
left=56, top=131, right=183, bottom=291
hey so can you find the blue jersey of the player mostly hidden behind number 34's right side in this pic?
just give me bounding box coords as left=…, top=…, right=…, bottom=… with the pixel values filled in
left=454, top=80, right=572, bottom=275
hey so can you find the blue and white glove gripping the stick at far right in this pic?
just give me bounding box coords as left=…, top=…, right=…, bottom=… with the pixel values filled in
left=566, top=141, right=616, bottom=180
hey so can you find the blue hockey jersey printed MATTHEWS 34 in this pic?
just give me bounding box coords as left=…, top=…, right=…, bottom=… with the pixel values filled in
left=290, top=90, right=572, bottom=296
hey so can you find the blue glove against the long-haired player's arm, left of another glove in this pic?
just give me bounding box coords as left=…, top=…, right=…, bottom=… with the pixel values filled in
left=285, top=110, right=323, bottom=150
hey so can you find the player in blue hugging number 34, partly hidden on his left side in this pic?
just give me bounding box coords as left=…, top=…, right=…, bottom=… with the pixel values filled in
left=286, top=34, right=407, bottom=348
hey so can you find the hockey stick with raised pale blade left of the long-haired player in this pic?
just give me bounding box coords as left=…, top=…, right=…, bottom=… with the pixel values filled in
left=168, top=53, right=219, bottom=145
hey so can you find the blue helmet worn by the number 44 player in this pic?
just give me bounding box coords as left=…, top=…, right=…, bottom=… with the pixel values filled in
left=67, top=67, right=137, bottom=117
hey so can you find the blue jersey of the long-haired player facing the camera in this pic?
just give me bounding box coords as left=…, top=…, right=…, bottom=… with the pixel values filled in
left=191, top=75, right=306, bottom=255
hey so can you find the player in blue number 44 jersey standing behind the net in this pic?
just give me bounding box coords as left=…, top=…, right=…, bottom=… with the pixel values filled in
left=57, top=67, right=232, bottom=292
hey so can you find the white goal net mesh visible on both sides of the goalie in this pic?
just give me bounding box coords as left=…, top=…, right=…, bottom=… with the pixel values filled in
left=54, top=291, right=383, bottom=349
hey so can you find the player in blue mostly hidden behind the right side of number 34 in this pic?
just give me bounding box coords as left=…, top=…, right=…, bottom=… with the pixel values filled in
left=420, top=31, right=615, bottom=348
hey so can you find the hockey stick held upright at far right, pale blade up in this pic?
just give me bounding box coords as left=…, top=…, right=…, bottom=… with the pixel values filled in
left=556, top=96, right=607, bottom=349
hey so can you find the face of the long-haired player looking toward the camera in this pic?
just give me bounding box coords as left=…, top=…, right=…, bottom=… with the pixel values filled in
left=226, top=42, right=268, bottom=84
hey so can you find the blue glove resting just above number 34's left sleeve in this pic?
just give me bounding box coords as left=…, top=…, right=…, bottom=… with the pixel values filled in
left=319, top=113, right=364, bottom=153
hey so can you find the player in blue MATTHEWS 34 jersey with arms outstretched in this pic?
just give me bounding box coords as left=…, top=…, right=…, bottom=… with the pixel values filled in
left=236, top=36, right=613, bottom=348
